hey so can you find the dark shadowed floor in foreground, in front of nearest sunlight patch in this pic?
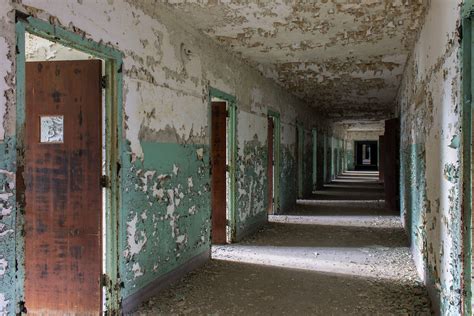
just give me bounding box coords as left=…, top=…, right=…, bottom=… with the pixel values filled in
left=137, top=260, right=430, bottom=315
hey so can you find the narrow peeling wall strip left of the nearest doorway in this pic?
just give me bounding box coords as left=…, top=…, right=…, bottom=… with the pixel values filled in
left=0, top=0, right=16, bottom=315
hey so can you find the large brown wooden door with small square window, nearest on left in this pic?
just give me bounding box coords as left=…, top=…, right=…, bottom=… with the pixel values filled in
left=24, top=60, right=102, bottom=315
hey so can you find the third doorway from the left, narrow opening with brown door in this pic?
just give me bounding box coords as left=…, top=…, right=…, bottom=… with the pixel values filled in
left=267, top=111, right=280, bottom=215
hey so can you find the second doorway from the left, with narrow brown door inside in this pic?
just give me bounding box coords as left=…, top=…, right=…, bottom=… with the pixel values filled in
left=209, top=88, right=236, bottom=245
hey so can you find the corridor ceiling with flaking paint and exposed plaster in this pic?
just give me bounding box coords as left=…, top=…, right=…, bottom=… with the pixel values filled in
left=136, top=0, right=427, bottom=121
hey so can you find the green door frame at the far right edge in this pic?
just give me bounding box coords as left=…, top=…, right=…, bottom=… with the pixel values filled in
left=461, top=0, right=474, bottom=315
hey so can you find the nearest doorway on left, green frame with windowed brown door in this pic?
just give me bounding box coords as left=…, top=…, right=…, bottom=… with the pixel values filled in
left=16, top=16, right=122, bottom=314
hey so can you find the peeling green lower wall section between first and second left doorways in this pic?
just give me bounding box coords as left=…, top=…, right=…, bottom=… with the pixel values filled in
left=120, top=141, right=211, bottom=297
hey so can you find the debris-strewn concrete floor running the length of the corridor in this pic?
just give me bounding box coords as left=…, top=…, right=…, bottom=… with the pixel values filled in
left=137, top=172, right=430, bottom=315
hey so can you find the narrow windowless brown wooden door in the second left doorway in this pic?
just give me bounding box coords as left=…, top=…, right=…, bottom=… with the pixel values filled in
left=211, top=102, right=227, bottom=244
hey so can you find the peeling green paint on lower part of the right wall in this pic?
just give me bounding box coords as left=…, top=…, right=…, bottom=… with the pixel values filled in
left=400, top=143, right=462, bottom=315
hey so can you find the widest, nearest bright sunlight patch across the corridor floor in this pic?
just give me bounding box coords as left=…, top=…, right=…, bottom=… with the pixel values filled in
left=212, top=244, right=416, bottom=281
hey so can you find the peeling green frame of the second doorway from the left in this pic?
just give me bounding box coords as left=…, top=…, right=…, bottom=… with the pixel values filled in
left=208, top=87, right=237, bottom=242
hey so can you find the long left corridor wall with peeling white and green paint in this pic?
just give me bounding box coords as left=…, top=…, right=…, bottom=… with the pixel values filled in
left=0, top=0, right=324, bottom=313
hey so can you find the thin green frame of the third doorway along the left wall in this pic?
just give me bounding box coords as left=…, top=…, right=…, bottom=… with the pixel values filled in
left=268, top=110, right=281, bottom=214
